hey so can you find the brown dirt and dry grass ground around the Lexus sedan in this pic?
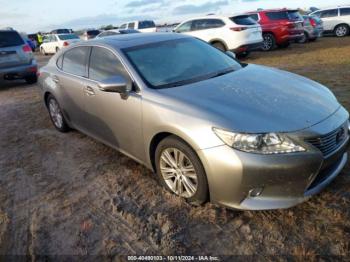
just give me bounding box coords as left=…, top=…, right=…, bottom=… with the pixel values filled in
left=0, top=37, right=350, bottom=261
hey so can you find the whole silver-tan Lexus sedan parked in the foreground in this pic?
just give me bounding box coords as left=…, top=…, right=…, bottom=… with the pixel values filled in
left=39, top=33, right=349, bottom=210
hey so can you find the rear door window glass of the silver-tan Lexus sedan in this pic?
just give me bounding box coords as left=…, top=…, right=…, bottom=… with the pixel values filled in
left=62, top=46, right=90, bottom=76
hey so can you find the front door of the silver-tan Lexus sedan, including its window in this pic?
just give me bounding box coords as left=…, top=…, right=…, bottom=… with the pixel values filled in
left=84, top=46, right=144, bottom=159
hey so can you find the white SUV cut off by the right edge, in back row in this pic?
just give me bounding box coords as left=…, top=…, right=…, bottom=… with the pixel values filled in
left=310, top=6, right=350, bottom=37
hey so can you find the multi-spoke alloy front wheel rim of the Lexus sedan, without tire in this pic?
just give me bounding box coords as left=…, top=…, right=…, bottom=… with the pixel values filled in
left=160, top=148, right=198, bottom=198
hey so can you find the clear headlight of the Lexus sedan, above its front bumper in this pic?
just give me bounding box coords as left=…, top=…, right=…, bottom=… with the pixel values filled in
left=213, top=128, right=306, bottom=155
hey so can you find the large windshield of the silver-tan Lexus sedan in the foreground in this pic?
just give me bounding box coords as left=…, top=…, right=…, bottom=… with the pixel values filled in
left=123, top=38, right=241, bottom=89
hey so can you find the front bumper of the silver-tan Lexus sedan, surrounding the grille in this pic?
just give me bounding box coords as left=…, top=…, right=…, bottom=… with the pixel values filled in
left=198, top=108, right=349, bottom=210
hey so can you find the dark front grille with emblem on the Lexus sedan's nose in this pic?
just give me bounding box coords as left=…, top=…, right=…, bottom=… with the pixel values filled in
left=305, top=125, right=349, bottom=156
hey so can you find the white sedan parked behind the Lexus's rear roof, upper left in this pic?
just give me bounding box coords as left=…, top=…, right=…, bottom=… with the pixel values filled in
left=40, top=34, right=81, bottom=55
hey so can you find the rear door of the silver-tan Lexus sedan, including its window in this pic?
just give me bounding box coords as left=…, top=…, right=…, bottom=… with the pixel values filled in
left=55, top=46, right=91, bottom=131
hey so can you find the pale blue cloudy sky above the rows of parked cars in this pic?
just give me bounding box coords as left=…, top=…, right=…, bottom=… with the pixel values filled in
left=0, top=0, right=350, bottom=33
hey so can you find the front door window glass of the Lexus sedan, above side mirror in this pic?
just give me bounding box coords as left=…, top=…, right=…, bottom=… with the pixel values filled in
left=89, top=47, right=131, bottom=83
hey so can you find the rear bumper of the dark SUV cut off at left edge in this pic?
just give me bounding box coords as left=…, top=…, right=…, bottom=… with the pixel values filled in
left=0, top=59, right=38, bottom=80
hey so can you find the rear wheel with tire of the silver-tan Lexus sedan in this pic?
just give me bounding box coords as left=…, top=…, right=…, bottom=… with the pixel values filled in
left=46, top=95, right=70, bottom=133
